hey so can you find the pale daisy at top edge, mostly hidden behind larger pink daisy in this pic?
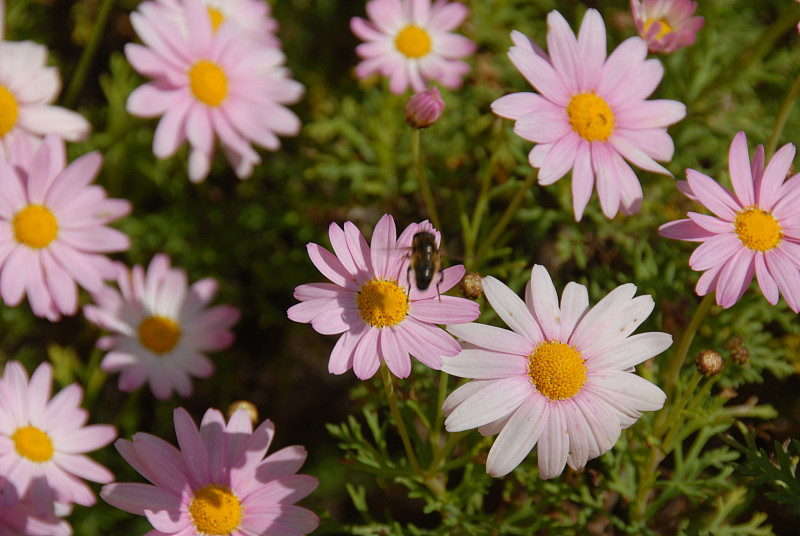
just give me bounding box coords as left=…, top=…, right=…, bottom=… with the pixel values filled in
left=156, top=0, right=281, bottom=47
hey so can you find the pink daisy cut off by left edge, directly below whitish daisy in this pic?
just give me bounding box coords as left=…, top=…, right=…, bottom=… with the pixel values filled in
left=0, top=134, right=131, bottom=321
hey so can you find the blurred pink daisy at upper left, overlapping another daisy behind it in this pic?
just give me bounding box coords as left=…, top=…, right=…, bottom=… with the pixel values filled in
left=125, top=0, right=303, bottom=182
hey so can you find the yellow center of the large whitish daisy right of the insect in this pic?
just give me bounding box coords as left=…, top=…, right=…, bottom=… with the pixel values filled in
left=528, top=341, right=586, bottom=400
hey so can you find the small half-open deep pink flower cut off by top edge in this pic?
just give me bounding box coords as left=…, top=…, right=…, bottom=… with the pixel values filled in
left=631, top=0, right=705, bottom=54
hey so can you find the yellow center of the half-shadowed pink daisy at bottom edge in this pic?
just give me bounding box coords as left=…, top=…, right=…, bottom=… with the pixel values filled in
left=189, top=484, right=244, bottom=536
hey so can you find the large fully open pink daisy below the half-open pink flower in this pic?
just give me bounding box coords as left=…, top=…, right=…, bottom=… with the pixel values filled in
left=492, top=9, right=686, bottom=220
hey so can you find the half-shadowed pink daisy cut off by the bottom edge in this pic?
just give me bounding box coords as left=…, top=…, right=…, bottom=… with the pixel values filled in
left=100, top=408, right=319, bottom=536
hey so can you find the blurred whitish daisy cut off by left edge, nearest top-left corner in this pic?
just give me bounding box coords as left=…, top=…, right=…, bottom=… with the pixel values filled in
left=0, top=41, right=91, bottom=159
